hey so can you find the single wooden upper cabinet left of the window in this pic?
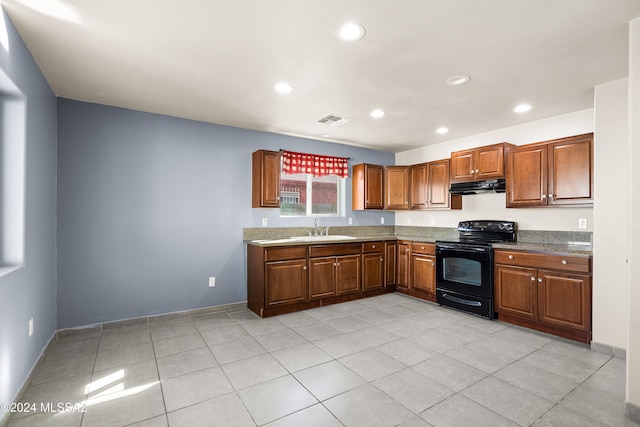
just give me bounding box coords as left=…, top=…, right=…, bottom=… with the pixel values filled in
left=251, top=150, right=280, bottom=208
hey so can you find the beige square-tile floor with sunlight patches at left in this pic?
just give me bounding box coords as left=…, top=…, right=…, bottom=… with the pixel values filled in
left=9, top=294, right=640, bottom=427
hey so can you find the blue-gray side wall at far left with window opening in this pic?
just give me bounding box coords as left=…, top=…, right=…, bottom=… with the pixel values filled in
left=0, top=10, right=56, bottom=422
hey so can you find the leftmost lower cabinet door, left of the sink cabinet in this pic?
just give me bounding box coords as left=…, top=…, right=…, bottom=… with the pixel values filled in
left=265, top=260, right=307, bottom=307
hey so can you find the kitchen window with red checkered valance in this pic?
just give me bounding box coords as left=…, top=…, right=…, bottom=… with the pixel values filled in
left=280, top=151, right=348, bottom=217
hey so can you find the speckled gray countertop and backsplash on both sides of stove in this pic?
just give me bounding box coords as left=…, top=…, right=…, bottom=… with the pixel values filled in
left=243, top=226, right=592, bottom=256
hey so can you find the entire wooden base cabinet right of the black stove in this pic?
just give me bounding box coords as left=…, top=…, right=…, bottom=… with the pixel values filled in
left=494, top=250, right=591, bottom=343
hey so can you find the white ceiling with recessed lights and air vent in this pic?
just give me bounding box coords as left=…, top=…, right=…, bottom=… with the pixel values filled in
left=1, top=0, right=640, bottom=152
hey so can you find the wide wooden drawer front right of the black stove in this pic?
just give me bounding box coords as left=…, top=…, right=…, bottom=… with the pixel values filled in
left=494, top=250, right=591, bottom=273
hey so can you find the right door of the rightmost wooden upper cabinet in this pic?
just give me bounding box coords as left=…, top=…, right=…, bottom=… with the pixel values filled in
left=547, top=134, right=593, bottom=205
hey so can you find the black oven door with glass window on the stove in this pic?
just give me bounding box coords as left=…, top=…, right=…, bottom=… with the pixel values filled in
left=436, top=242, right=493, bottom=299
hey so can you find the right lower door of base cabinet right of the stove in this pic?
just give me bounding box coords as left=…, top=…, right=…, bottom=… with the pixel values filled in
left=538, top=270, right=591, bottom=331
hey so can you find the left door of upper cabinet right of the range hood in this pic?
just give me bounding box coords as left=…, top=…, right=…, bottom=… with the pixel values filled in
left=506, top=144, right=547, bottom=208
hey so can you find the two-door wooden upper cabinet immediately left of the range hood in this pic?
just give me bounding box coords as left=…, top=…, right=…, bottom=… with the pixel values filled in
left=409, top=159, right=462, bottom=210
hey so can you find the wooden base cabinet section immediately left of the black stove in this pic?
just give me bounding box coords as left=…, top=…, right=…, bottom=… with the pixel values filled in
left=396, top=240, right=436, bottom=301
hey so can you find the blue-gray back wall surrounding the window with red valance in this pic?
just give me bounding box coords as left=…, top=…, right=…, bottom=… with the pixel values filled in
left=58, top=99, right=394, bottom=328
